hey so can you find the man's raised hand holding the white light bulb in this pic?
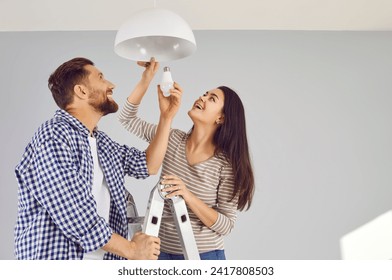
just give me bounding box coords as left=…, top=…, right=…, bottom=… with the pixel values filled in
left=158, top=82, right=183, bottom=119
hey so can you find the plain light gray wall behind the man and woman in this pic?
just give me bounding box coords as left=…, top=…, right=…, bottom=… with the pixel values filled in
left=0, top=31, right=392, bottom=259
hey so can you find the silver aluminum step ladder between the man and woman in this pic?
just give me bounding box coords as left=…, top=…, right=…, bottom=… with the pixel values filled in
left=127, top=182, right=200, bottom=260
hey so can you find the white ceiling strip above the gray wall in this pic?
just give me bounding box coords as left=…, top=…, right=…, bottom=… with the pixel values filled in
left=0, top=0, right=392, bottom=31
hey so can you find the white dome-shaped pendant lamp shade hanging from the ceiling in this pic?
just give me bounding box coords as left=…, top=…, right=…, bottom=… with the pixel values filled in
left=114, top=8, right=196, bottom=61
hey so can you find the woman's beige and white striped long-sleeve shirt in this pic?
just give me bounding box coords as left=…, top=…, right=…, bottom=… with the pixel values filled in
left=119, top=101, right=237, bottom=254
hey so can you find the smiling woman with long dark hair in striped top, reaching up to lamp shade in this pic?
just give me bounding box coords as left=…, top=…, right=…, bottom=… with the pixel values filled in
left=120, top=59, right=254, bottom=259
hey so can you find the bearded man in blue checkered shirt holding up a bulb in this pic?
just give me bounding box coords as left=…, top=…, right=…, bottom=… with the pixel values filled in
left=15, top=58, right=182, bottom=259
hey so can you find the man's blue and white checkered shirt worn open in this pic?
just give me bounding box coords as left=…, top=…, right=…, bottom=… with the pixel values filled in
left=15, top=110, right=148, bottom=259
